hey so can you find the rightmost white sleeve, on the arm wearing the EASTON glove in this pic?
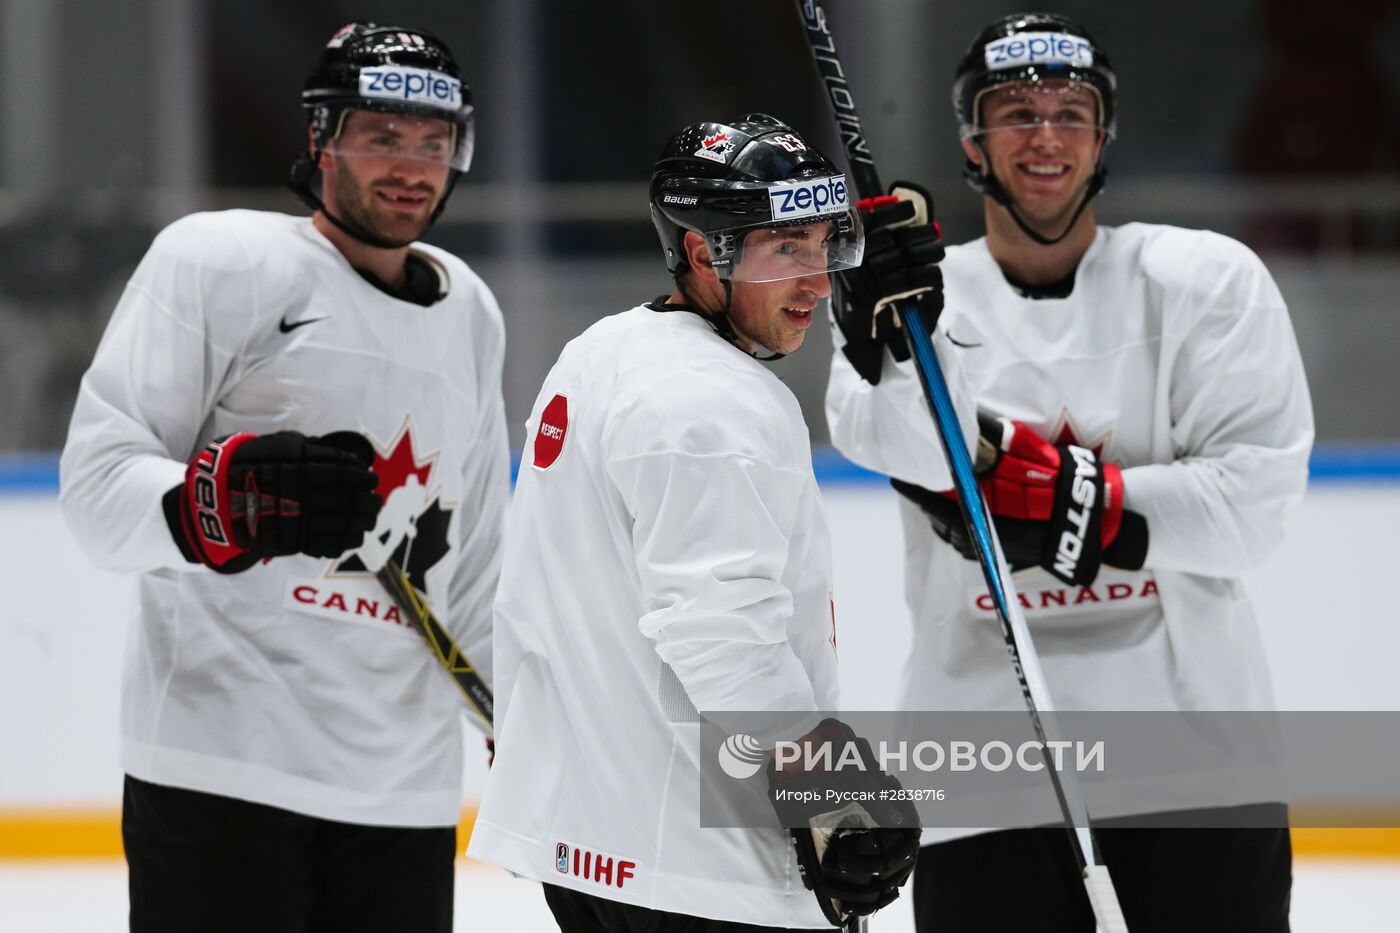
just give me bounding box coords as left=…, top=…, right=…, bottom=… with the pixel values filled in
left=1123, top=237, right=1313, bottom=577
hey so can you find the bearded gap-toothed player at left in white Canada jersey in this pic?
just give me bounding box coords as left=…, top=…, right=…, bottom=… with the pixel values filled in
left=62, top=22, right=510, bottom=933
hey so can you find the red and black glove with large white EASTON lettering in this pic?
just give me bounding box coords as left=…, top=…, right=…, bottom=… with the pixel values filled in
left=892, top=416, right=1148, bottom=586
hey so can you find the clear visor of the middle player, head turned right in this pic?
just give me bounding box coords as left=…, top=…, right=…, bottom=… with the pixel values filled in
left=707, top=210, right=865, bottom=282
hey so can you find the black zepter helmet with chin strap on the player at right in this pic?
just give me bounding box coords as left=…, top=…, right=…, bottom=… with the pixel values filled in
left=952, top=13, right=1117, bottom=244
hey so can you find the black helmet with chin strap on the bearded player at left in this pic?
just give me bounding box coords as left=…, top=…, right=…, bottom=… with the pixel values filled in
left=288, top=22, right=476, bottom=247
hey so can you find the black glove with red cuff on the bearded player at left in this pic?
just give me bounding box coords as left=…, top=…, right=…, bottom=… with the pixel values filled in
left=164, top=431, right=384, bottom=573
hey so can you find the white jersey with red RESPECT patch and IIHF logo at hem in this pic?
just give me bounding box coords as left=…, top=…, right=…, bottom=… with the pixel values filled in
left=468, top=307, right=837, bottom=927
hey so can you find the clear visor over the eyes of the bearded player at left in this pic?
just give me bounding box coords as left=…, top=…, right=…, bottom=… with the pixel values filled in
left=325, top=109, right=476, bottom=172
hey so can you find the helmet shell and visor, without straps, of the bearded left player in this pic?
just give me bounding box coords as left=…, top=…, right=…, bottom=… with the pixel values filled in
left=301, top=22, right=475, bottom=172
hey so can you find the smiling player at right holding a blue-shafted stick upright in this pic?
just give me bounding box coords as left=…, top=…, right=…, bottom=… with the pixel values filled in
left=827, top=14, right=1313, bottom=933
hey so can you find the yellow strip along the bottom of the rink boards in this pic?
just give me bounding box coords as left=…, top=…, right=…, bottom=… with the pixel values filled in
left=0, top=807, right=1400, bottom=860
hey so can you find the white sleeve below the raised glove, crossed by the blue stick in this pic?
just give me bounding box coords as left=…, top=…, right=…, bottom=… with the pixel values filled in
left=826, top=319, right=977, bottom=490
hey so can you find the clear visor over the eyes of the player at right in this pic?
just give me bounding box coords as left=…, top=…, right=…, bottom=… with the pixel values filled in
left=962, top=81, right=1106, bottom=141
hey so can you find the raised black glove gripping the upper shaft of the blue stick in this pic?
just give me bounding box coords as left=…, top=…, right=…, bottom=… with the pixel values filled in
left=832, top=182, right=944, bottom=385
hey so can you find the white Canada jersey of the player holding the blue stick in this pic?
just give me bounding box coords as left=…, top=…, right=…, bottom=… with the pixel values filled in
left=826, top=224, right=1313, bottom=710
